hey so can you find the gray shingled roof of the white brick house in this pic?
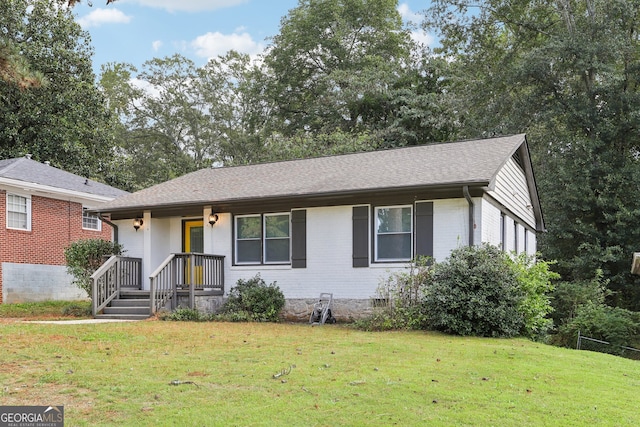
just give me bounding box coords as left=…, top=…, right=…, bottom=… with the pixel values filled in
left=99, top=134, right=525, bottom=212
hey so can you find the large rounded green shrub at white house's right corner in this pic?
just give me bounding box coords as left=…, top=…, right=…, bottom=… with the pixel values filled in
left=424, top=244, right=524, bottom=337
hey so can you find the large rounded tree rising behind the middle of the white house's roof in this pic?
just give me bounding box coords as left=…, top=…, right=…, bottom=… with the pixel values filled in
left=265, top=0, right=411, bottom=135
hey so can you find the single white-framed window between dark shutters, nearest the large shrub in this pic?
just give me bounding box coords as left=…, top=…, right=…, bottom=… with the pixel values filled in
left=375, top=205, right=413, bottom=261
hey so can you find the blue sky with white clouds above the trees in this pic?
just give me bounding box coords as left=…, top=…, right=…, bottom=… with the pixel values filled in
left=74, top=0, right=432, bottom=73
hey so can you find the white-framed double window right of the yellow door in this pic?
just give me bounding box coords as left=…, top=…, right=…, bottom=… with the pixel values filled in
left=235, top=213, right=291, bottom=264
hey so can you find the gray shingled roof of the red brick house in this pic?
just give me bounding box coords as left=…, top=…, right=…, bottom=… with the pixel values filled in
left=0, top=157, right=130, bottom=198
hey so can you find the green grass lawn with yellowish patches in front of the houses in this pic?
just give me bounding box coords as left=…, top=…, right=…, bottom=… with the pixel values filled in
left=0, top=319, right=640, bottom=426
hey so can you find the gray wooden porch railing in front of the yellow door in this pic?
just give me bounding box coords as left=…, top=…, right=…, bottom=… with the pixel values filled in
left=149, top=253, right=224, bottom=314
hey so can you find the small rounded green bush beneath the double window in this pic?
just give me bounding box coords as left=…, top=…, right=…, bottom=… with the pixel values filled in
left=220, top=274, right=285, bottom=322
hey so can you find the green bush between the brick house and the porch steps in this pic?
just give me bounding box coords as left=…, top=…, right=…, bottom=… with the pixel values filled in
left=64, top=239, right=123, bottom=298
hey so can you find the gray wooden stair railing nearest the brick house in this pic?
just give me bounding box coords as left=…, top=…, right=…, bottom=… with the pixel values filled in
left=91, top=255, right=142, bottom=316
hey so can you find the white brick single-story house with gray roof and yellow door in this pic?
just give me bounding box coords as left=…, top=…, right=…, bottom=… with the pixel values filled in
left=92, top=135, right=544, bottom=319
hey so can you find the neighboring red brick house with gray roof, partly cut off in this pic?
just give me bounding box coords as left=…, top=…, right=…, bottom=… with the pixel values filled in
left=0, top=157, right=128, bottom=303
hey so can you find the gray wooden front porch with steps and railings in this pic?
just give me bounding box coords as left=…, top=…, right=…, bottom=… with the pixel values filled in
left=91, top=252, right=224, bottom=319
